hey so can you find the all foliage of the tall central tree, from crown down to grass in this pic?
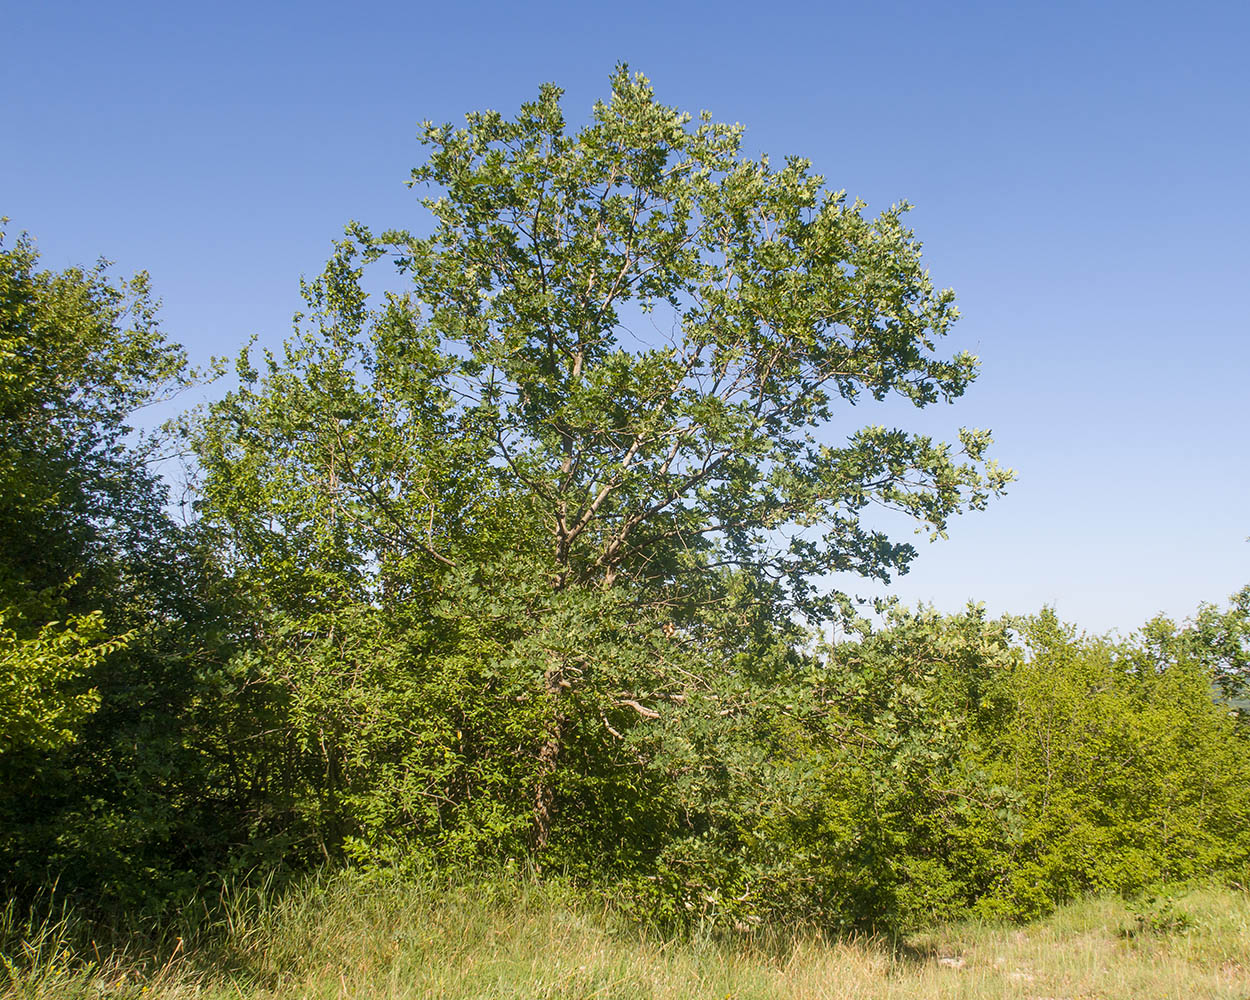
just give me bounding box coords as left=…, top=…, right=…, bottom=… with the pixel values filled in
left=191, top=69, right=1010, bottom=880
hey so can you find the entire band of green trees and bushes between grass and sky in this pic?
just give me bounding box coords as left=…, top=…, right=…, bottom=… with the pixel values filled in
left=0, top=68, right=1250, bottom=926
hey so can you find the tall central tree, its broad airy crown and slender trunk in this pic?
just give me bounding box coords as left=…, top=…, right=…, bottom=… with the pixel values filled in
left=199, top=66, right=1011, bottom=860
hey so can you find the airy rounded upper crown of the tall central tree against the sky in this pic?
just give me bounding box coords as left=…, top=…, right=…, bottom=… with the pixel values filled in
left=200, top=68, right=1011, bottom=625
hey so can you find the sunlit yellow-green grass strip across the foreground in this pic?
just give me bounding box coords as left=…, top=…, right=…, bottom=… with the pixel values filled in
left=0, top=879, right=1250, bottom=1000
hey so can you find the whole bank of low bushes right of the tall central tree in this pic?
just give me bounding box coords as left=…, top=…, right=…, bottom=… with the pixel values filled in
left=641, top=597, right=1250, bottom=928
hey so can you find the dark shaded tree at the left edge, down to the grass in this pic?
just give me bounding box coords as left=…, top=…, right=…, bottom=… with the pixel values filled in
left=0, top=225, right=245, bottom=904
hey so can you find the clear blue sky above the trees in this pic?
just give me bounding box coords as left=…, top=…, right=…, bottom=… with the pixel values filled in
left=0, top=0, right=1250, bottom=631
